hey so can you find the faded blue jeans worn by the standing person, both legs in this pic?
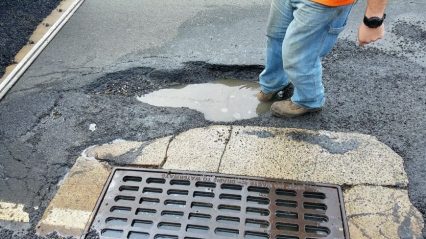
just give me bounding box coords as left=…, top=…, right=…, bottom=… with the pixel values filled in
left=259, top=0, right=352, bottom=109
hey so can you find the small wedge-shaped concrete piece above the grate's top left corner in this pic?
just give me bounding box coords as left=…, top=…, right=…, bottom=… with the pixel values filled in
left=132, top=136, right=172, bottom=167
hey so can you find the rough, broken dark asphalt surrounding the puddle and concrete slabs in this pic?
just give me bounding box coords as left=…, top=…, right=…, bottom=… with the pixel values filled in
left=0, top=41, right=426, bottom=236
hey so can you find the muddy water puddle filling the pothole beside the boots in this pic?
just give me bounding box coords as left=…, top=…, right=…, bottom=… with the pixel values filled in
left=137, top=79, right=271, bottom=122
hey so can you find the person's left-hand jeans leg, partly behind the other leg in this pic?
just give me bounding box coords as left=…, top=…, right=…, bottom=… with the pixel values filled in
left=259, top=0, right=293, bottom=94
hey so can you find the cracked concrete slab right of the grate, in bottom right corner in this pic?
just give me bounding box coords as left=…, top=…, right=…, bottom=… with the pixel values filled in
left=344, top=186, right=424, bottom=239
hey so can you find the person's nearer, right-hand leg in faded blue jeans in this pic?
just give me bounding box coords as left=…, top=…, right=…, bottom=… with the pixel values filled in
left=283, top=0, right=352, bottom=109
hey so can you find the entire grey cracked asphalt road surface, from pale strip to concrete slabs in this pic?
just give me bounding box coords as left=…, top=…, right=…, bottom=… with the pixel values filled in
left=0, top=0, right=426, bottom=238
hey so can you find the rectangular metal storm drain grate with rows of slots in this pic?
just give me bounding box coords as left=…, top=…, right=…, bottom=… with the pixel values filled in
left=87, top=168, right=349, bottom=239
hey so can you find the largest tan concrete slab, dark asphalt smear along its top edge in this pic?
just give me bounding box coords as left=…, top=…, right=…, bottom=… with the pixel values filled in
left=220, top=126, right=408, bottom=186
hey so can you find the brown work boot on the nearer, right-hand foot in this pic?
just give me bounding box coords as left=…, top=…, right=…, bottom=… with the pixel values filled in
left=271, top=100, right=321, bottom=117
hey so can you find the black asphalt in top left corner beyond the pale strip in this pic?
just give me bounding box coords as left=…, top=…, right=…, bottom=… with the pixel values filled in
left=0, top=0, right=61, bottom=77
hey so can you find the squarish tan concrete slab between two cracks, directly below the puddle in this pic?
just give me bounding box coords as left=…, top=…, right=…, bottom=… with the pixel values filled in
left=163, top=126, right=231, bottom=172
